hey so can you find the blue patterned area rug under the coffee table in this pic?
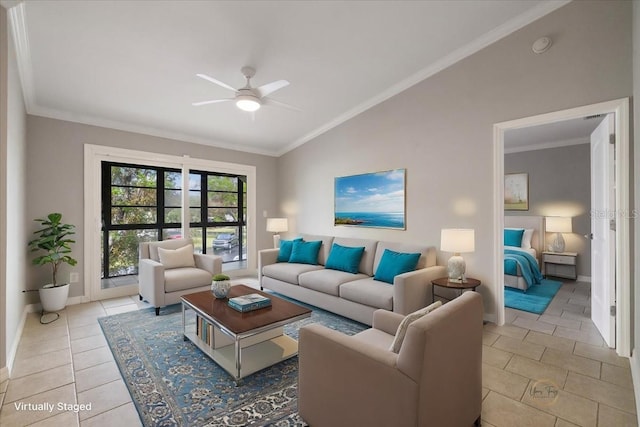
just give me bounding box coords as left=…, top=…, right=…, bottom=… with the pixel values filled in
left=98, top=298, right=368, bottom=427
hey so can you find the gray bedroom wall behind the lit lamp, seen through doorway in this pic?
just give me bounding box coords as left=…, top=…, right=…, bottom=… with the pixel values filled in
left=504, top=144, right=591, bottom=277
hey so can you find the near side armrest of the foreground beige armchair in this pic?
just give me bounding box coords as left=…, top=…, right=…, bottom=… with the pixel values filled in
left=298, top=324, right=419, bottom=427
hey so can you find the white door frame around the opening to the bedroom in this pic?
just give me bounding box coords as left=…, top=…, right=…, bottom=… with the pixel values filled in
left=493, top=98, right=632, bottom=357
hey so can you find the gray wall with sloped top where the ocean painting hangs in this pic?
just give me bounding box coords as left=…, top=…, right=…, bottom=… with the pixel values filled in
left=278, top=1, right=632, bottom=315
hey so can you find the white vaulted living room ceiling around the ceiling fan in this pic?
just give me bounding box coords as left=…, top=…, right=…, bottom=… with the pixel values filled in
left=2, top=0, right=566, bottom=155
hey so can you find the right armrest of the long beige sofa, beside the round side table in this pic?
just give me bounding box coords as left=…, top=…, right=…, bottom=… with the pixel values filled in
left=393, top=265, right=447, bottom=314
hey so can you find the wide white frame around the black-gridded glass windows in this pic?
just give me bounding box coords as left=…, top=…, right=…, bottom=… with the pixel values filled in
left=81, top=144, right=257, bottom=302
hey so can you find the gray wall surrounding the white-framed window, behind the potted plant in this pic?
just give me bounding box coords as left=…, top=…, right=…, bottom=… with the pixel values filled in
left=26, top=116, right=277, bottom=302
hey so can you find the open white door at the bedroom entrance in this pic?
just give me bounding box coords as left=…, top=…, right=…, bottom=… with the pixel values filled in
left=591, top=114, right=616, bottom=348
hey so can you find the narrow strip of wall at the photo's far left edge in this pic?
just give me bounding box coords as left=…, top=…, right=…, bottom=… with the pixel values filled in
left=0, top=7, right=28, bottom=377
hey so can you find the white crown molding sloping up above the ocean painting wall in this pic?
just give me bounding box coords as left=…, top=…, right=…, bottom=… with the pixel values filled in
left=279, top=0, right=571, bottom=155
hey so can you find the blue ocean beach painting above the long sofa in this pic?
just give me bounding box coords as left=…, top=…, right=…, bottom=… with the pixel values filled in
left=334, top=169, right=406, bottom=230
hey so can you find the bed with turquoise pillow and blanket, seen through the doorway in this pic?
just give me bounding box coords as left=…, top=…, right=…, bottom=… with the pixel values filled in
left=504, top=216, right=543, bottom=291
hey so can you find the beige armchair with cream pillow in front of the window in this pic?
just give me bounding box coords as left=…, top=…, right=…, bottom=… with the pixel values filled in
left=138, top=239, right=222, bottom=316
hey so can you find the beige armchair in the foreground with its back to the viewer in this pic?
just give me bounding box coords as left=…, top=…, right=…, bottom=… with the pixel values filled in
left=298, top=292, right=483, bottom=427
